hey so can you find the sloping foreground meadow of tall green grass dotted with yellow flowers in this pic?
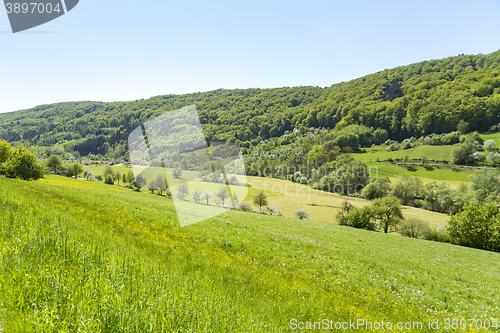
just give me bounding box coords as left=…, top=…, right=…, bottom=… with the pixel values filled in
left=0, top=176, right=500, bottom=332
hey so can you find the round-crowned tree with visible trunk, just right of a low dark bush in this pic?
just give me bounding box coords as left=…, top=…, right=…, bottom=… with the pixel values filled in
left=369, top=195, right=403, bottom=233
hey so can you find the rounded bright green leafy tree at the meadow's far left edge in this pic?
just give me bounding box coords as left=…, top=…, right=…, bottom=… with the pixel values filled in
left=3, top=145, right=45, bottom=180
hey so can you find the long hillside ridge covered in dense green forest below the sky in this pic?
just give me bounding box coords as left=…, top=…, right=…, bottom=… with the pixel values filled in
left=0, top=51, right=500, bottom=156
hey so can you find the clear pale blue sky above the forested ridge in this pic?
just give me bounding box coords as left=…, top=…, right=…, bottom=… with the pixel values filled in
left=0, top=0, right=500, bottom=112
